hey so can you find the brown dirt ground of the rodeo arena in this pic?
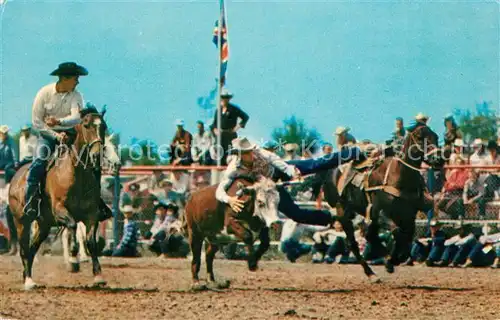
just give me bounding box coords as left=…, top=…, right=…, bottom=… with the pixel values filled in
left=0, top=257, right=500, bottom=319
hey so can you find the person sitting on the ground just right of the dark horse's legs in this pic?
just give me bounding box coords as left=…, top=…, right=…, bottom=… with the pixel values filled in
left=408, top=219, right=446, bottom=267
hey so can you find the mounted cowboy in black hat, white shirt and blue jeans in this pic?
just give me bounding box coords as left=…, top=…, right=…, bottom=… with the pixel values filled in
left=24, top=62, right=88, bottom=219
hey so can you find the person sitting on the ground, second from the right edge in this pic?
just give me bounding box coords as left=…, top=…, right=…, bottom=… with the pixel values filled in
left=436, top=223, right=477, bottom=267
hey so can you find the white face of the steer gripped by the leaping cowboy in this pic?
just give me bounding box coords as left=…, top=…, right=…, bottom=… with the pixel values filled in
left=239, top=178, right=280, bottom=227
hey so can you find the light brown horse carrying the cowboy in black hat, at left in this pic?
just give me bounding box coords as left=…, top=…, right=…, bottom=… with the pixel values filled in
left=9, top=110, right=106, bottom=290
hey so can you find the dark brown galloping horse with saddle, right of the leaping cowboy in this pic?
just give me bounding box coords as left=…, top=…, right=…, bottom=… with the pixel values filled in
left=323, top=124, right=442, bottom=280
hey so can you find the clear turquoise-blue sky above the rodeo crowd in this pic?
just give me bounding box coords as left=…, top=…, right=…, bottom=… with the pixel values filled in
left=0, top=0, right=500, bottom=143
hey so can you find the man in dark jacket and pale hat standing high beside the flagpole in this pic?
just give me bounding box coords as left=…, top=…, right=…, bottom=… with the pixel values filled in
left=210, top=88, right=249, bottom=165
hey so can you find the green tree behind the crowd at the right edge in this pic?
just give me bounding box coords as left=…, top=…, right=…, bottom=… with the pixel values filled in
left=453, top=101, right=500, bottom=143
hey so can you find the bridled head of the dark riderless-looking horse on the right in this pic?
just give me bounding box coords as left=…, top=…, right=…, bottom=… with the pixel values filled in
left=402, top=124, right=441, bottom=166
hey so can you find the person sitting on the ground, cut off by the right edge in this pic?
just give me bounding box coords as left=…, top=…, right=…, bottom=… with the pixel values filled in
left=462, top=226, right=500, bottom=268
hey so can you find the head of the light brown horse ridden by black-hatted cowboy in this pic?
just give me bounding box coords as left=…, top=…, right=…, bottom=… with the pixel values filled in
left=77, top=107, right=107, bottom=167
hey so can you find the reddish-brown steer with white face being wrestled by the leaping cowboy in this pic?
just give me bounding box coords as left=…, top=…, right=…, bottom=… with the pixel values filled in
left=185, top=178, right=279, bottom=289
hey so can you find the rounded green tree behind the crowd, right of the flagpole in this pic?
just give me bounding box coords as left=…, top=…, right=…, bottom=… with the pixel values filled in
left=271, top=116, right=321, bottom=158
